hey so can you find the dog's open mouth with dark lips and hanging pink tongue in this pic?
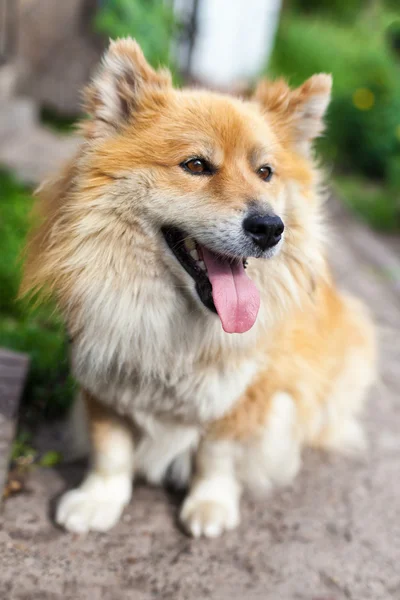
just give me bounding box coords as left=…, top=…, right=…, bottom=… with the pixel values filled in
left=162, top=227, right=260, bottom=333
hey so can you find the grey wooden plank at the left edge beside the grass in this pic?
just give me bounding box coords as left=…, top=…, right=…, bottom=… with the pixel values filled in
left=0, top=348, right=29, bottom=498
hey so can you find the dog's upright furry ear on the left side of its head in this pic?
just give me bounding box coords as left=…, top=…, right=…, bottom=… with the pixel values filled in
left=83, top=38, right=171, bottom=137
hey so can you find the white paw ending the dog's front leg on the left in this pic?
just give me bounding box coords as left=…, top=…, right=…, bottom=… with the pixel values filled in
left=56, top=475, right=131, bottom=533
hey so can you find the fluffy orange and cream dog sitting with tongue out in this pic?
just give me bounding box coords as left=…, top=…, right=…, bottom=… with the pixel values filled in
left=23, top=39, right=375, bottom=537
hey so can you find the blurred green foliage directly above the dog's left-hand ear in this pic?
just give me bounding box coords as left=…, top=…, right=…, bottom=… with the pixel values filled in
left=95, top=0, right=177, bottom=67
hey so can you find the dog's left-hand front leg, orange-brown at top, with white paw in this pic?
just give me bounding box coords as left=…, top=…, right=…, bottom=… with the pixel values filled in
left=56, top=394, right=134, bottom=533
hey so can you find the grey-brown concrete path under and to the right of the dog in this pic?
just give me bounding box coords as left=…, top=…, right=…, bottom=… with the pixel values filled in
left=0, top=203, right=400, bottom=600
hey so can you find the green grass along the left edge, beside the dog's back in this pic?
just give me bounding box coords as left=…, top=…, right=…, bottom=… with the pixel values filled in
left=0, top=172, right=73, bottom=421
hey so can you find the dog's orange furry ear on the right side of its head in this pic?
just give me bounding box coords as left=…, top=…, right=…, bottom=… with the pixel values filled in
left=254, top=73, right=332, bottom=153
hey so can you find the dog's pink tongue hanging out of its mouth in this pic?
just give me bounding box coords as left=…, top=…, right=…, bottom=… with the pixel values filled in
left=201, top=247, right=260, bottom=333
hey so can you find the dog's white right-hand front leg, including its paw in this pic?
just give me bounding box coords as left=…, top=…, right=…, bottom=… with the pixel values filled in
left=181, top=439, right=241, bottom=537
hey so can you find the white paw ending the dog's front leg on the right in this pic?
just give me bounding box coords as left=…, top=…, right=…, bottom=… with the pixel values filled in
left=181, top=496, right=240, bottom=538
